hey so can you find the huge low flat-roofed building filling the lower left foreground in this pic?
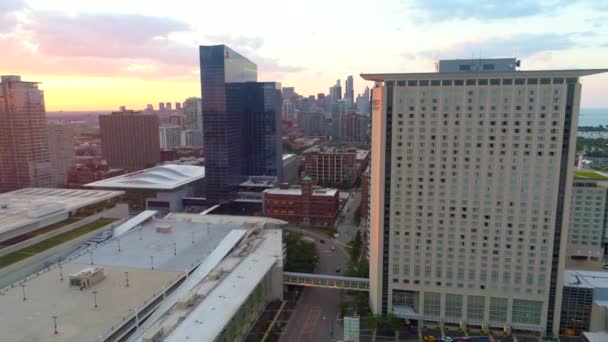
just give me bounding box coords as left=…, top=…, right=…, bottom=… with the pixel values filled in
left=0, top=214, right=286, bottom=342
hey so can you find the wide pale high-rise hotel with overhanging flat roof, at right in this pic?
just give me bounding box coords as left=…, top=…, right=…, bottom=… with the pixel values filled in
left=362, top=59, right=608, bottom=335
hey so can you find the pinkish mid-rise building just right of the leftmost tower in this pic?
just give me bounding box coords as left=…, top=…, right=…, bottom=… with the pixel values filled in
left=48, top=123, right=76, bottom=188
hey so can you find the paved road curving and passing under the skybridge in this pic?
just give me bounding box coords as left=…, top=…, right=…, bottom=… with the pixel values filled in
left=281, top=193, right=361, bottom=342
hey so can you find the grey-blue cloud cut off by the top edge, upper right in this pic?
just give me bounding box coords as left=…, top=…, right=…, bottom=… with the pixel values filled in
left=412, top=0, right=573, bottom=21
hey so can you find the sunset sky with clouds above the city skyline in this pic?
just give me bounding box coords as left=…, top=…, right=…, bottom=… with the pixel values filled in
left=0, top=0, right=608, bottom=111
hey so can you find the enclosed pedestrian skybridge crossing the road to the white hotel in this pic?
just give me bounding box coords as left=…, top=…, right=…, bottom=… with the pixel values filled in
left=283, top=272, right=369, bottom=291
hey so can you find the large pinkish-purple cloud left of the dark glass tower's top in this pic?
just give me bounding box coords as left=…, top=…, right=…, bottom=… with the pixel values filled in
left=24, top=12, right=196, bottom=64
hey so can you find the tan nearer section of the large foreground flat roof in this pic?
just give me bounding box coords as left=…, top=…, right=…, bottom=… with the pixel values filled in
left=0, top=263, right=183, bottom=342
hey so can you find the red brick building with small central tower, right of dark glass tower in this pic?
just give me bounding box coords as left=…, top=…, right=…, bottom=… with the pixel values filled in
left=264, top=177, right=339, bottom=225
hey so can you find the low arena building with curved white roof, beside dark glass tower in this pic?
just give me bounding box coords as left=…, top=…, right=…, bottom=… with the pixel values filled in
left=86, top=164, right=205, bottom=213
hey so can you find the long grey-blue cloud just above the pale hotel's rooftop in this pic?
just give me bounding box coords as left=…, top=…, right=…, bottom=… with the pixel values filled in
left=418, top=33, right=577, bottom=59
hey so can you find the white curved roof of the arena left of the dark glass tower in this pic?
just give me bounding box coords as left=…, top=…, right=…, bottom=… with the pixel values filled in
left=85, top=164, right=205, bottom=190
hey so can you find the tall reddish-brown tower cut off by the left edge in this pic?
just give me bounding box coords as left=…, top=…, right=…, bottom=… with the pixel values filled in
left=0, top=76, right=51, bottom=192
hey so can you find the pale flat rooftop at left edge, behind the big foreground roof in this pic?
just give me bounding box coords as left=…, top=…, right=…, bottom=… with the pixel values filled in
left=0, top=188, right=124, bottom=233
